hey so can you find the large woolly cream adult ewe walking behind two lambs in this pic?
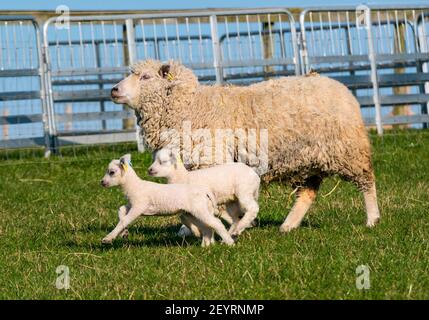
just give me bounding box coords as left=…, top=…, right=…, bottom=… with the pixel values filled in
left=111, top=60, right=380, bottom=232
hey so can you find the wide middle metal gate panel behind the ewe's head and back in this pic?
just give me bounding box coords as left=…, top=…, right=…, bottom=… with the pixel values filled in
left=43, top=9, right=299, bottom=149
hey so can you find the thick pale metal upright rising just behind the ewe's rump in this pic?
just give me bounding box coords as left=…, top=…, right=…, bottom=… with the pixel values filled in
left=362, top=5, right=383, bottom=136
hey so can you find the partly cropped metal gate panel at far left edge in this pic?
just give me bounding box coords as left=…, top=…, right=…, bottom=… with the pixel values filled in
left=0, top=16, right=49, bottom=153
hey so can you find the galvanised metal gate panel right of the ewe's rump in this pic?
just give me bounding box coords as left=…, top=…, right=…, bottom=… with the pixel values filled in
left=300, top=6, right=429, bottom=134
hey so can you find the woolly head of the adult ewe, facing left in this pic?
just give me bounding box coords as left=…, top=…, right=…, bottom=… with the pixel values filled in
left=111, top=60, right=198, bottom=110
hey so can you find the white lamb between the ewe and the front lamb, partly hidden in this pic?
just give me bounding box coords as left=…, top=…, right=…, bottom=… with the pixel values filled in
left=148, top=148, right=260, bottom=237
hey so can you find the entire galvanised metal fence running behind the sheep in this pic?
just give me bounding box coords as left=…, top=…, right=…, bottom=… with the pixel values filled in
left=0, top=6, right=429, bottom=152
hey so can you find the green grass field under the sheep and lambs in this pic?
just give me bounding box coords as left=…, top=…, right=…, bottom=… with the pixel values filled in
left=0, top=131, right=429, bottom=299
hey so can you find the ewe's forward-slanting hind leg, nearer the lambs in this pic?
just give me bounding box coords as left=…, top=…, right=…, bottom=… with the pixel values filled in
left=280, top=177, right=322, bottom=232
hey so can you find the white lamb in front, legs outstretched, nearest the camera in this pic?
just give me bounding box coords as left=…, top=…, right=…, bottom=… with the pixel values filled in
left=101, top=154, right=234, bottom=247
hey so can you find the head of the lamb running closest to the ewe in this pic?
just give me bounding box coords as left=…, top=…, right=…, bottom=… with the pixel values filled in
left=148, top=148, right=184, bottom=178
